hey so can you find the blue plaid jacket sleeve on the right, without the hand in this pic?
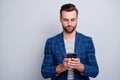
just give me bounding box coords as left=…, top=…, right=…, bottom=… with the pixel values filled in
left=83, top=38, right=99, bottom=77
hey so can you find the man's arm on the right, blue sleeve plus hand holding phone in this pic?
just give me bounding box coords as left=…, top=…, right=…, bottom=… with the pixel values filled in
left=68, top=38, right=99, bottom=77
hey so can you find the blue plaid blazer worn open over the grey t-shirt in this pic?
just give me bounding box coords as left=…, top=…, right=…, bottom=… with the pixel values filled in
left=41, top=32, right=99, bottom=80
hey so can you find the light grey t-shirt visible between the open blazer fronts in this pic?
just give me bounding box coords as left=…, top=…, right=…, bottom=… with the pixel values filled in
left=64, top=37, right=75, bottom=80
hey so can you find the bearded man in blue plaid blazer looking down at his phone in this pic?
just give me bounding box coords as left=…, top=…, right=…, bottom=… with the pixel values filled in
left=41, top=3, right=99, bottom=80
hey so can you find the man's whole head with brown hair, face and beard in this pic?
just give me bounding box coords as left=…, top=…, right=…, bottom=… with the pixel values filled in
left=60, top=3, right=78, bottom=33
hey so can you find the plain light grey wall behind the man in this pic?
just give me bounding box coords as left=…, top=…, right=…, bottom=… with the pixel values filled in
left=0, top=0, right=120, bottom=80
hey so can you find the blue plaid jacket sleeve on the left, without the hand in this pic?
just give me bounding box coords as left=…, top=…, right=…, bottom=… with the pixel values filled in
left=41, top=39, right=56, bottom=78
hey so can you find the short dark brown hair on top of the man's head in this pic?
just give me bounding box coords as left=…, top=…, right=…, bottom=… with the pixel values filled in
left=60, top=3, right=78, bottom=17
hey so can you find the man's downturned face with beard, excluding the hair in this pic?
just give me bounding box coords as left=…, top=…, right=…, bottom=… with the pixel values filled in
left=60, top=10, right=78, bottom=33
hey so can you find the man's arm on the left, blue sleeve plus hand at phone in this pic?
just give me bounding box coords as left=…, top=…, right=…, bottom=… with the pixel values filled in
left=41, top=39, right=71, bottom=78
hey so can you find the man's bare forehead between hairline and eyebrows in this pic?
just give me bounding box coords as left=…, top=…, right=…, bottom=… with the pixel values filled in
left=62, top=10, right=77, bottom=18
